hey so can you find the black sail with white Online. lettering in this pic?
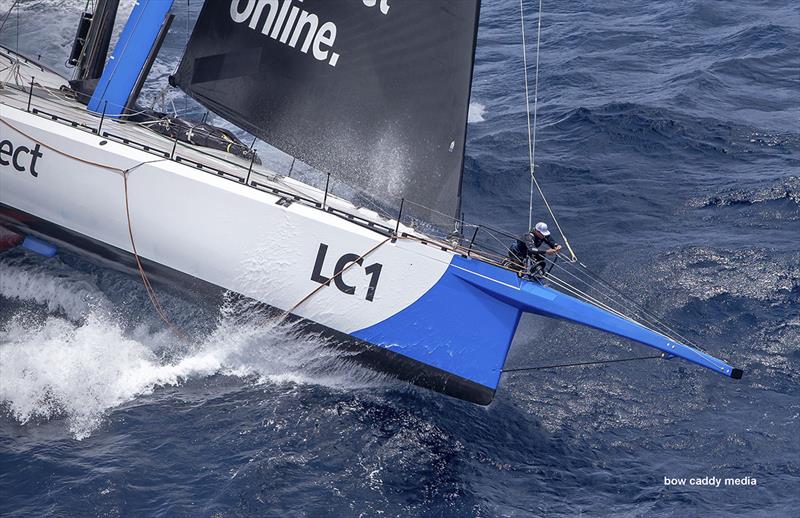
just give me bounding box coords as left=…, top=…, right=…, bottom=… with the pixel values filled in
left=172, top=0, right=480, bottom=221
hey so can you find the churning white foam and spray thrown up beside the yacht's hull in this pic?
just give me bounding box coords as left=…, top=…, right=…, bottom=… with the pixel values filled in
left=0, top=258, right=394, bottom=439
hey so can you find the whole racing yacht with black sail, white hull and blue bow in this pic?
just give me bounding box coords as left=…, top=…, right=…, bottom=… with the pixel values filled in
left=0, top=0, right=742, bottom=405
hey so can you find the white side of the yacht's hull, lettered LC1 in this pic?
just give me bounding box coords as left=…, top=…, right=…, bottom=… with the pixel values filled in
left=0, top=105, right=452, bottom=333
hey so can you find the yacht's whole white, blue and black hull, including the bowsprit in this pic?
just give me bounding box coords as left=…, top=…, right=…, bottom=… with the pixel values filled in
left=0, top=53, right=741, bottom=404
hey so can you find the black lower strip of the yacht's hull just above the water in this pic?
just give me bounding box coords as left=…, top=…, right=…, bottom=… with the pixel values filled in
left=0, top=204, right=494, bottom=405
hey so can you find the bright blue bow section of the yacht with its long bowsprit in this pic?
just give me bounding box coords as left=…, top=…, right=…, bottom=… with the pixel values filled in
left=353, top=256, right=742, bottom=404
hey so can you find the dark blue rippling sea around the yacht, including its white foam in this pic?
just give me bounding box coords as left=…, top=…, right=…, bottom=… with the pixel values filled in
left=0, top=0, right=800, bottom=517
